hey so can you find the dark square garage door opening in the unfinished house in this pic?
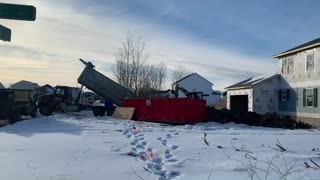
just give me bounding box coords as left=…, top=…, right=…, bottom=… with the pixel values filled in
left=230, top=95, right=249, bottom=112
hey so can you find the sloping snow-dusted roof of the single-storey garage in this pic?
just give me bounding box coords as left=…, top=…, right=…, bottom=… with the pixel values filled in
left=225, top=74, right=278, bottom=90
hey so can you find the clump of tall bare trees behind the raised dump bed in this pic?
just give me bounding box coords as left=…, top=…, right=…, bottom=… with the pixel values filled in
left=113, top=33, right=167, bottom=97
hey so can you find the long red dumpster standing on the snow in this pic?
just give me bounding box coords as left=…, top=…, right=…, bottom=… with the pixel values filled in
left=123, top=98, right=206, bottom=124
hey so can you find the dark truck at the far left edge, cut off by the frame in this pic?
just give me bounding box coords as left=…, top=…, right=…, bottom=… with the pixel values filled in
left=0, top=89, right=37, bottom=124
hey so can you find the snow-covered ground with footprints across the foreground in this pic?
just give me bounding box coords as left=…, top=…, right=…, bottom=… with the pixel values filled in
left=0, top=112, right=320, bottom=180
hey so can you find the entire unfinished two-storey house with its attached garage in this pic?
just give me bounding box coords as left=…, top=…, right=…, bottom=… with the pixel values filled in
left=226, top=38, right=320, bottom=126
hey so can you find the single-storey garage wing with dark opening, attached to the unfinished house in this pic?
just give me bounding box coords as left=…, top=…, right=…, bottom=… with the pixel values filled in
left=226, top=74, right=279, bottom=114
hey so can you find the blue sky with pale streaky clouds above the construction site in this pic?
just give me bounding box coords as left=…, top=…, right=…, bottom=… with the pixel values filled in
left=0, top=0, right=320, bottom=90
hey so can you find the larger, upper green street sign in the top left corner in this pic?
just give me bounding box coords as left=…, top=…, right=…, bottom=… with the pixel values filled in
left=0, top=3, right=36, bottom=21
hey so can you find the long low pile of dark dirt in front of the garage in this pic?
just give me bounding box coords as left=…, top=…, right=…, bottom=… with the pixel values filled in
left=207, top=107, right=312, bottom=129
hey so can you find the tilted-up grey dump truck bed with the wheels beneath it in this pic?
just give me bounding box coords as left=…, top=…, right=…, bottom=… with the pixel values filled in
left=78, top=59, right=134, bottom=116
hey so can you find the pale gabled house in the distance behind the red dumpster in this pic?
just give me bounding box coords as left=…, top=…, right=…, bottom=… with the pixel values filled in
left=172, top=73, right=221, bottom=106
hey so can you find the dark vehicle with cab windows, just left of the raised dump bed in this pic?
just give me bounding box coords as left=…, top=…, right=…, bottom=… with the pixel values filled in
left=38, top=86, right=81, bottom=116
